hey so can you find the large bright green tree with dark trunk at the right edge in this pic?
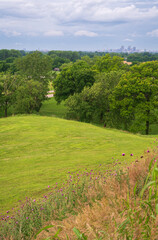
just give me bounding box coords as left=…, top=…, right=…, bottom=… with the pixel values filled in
left=111, top=61, right=158, bottom=134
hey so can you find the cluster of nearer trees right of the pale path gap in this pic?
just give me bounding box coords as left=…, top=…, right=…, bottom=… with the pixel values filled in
left=53, top=54, right=158, bottom=134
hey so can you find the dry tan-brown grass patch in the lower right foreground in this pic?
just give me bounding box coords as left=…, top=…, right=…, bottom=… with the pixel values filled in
left=35, top=152, right=158, bottom=240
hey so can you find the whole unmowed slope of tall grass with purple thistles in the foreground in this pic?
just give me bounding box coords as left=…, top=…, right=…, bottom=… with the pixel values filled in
left=0, top=142, right=158, bottom=240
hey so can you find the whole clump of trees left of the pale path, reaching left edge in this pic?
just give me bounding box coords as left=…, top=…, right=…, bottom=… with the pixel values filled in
left=0, top=52, right=52, bottom=117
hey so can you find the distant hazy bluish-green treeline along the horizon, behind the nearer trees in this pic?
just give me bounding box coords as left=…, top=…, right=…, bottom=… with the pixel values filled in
left=0, top=49, right=158, bottom=73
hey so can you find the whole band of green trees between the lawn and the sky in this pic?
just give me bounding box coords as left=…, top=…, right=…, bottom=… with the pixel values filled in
left=0, top=50, right=158, bottom=134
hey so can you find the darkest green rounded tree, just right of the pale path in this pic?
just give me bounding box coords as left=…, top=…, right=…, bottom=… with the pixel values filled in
left=53, top=60, right=96, bottom=103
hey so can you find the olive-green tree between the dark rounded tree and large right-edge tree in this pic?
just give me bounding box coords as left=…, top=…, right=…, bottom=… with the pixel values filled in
left=65, top=71, right=122, bottom=124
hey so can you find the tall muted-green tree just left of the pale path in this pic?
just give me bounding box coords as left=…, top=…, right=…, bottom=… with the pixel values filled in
left=15, top=51, right=52, bottom=113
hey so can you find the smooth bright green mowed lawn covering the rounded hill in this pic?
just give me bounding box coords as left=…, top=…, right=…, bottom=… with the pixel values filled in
left=0, top=115, right=156, bottom=212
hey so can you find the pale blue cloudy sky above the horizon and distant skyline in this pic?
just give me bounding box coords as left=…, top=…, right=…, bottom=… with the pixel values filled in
left=0, top=0, right=158, bottom=51
